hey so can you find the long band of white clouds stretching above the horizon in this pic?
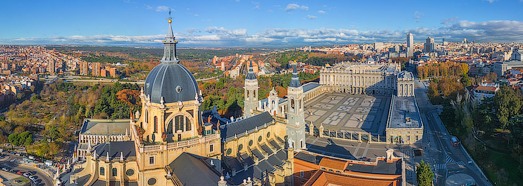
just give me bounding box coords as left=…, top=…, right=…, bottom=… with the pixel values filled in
left=6, top=20, right=523, bottom=47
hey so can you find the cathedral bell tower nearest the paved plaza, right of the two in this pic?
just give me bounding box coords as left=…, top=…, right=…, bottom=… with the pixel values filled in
left=287, top=63, right=306, bottom=152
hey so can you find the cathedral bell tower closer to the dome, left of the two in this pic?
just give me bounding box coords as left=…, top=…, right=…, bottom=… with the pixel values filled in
left=243, top=61, right=258, bottom=118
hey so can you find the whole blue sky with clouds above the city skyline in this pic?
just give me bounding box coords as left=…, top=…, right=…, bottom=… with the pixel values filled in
left=0, top=0, right=523, bottom=47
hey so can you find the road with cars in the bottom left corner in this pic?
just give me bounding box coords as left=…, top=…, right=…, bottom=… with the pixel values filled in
left=0, top=153, right=53, bottom=185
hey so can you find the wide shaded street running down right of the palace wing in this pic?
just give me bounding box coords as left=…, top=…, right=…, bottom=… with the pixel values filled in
left=414, top=80, right=492, bottom=185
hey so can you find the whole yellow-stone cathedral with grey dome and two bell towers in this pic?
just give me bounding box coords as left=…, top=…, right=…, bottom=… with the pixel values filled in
left=69, top=13, right=305, bottom=185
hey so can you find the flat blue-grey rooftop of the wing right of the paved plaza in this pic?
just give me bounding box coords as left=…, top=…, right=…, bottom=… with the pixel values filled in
left=387, top=95, right=422, bottom=128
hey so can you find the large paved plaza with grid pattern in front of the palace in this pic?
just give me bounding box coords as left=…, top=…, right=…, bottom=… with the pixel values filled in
left=305, top=93, right=390, bottom=135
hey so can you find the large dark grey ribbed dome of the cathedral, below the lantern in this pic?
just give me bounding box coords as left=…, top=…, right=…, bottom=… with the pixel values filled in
left=144, top=63, right=199, bottom=103
